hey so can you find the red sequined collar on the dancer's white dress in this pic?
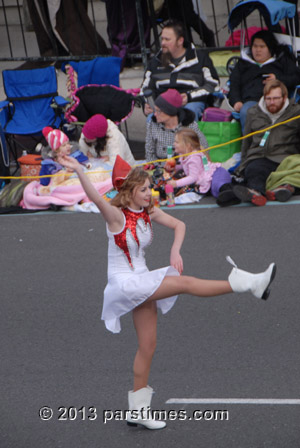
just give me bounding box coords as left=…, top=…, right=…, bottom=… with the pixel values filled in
left=114, top=208, right=152, bottom=268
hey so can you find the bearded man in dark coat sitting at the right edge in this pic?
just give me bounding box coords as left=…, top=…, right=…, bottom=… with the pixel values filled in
left=217, top=80, right=300, bottom=206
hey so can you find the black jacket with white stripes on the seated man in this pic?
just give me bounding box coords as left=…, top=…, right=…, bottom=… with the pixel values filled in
left=142, top=44, right=219, bottom=102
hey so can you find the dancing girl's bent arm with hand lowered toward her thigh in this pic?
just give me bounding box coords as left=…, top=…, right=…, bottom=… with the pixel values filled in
left=151, top=207, right=185, bottom=274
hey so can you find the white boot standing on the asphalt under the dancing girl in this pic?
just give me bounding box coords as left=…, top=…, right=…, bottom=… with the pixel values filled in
left=127, top=386, right=166, bottom=429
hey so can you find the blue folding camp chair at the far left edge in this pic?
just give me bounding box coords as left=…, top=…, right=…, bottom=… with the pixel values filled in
left=0, top=66, right=67, bottom=170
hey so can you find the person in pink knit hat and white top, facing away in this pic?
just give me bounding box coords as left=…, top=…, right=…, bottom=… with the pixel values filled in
left=79, top=114, right=135, bottom=166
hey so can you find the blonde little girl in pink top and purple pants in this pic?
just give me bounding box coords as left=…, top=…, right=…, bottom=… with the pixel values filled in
left=168, top=128, right=231, bottom=197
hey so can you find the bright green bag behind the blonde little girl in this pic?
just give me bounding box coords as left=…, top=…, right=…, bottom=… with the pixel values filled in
left=198, top=121, right=242, bottom=162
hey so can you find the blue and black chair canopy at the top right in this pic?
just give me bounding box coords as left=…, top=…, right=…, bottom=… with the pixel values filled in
left=228, top=0, right=296, bottom=31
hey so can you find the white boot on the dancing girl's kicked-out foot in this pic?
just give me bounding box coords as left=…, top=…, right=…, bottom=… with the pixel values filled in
left=226, top=256, right=276, bottom=300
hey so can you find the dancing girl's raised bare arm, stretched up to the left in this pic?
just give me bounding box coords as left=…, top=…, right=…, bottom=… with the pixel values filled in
left=58, top=156, right=123, bottom=232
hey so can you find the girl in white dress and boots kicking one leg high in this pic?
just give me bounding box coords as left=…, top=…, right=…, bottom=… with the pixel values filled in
left=59, top=156, right=275, bottom=429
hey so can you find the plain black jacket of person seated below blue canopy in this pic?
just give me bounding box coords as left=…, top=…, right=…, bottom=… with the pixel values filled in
left=229, top=49, right=300, bottom=106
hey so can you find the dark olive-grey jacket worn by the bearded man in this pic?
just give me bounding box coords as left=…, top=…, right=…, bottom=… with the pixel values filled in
left=236, top=100, right=300, bottom=174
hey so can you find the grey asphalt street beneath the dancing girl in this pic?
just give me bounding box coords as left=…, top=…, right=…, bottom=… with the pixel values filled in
left=0, top=201, right=300, bottom=448
